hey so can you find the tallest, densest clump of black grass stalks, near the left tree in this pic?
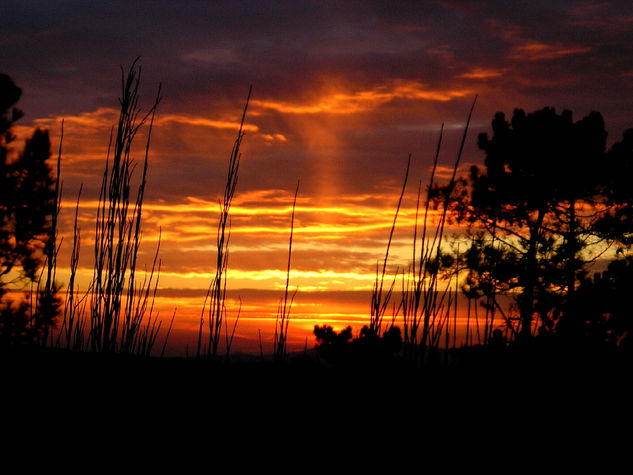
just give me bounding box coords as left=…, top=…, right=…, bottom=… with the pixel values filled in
left=88, top=61, right=160, bottom=354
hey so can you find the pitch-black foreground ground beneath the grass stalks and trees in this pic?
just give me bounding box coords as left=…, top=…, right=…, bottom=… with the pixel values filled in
left=0, top=348, right=633, bottom=473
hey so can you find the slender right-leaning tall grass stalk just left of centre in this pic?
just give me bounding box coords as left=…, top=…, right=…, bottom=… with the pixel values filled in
left=196, top=86, right=253, bottom=359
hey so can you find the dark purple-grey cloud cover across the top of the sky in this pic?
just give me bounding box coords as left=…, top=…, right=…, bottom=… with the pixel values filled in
left=0, top=0, right=633, bottom=197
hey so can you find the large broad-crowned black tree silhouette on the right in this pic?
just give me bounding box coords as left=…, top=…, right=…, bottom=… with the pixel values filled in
left=437, top=107, right=633, bottom=348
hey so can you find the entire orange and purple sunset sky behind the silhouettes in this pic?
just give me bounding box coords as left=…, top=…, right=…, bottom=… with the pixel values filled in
left=0, top=0, right=633, bottom=356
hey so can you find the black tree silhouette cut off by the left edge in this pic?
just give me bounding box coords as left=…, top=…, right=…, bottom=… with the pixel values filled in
left=0, top=74, right=58, bottom=343
